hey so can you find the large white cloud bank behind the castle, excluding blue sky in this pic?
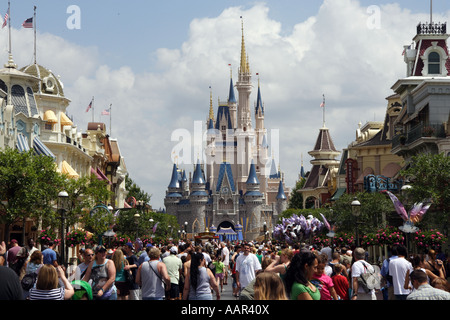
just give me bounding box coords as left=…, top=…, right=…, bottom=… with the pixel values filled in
left=4, top=0, right=445, bottom=208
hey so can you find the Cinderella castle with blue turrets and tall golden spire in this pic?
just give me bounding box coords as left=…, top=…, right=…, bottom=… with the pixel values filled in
left=164, top=21, right=289, bottom=240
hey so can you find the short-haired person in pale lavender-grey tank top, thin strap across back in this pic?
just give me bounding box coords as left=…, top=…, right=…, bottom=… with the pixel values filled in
left=136, top=247, right=170, bottom=300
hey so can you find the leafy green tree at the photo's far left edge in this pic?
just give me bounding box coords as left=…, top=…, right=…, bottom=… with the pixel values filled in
left=0, top=148, right=63, bottom=240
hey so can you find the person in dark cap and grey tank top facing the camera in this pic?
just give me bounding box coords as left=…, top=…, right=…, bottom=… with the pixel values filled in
left=82, top=246, right=117, bottom=300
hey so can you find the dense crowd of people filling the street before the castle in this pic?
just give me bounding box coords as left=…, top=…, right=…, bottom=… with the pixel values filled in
left=0, top=239, right=450, bottom=300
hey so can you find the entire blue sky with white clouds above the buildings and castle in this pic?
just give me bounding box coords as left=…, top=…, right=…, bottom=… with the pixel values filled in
left=0, top=0, right=450, bottom=208
